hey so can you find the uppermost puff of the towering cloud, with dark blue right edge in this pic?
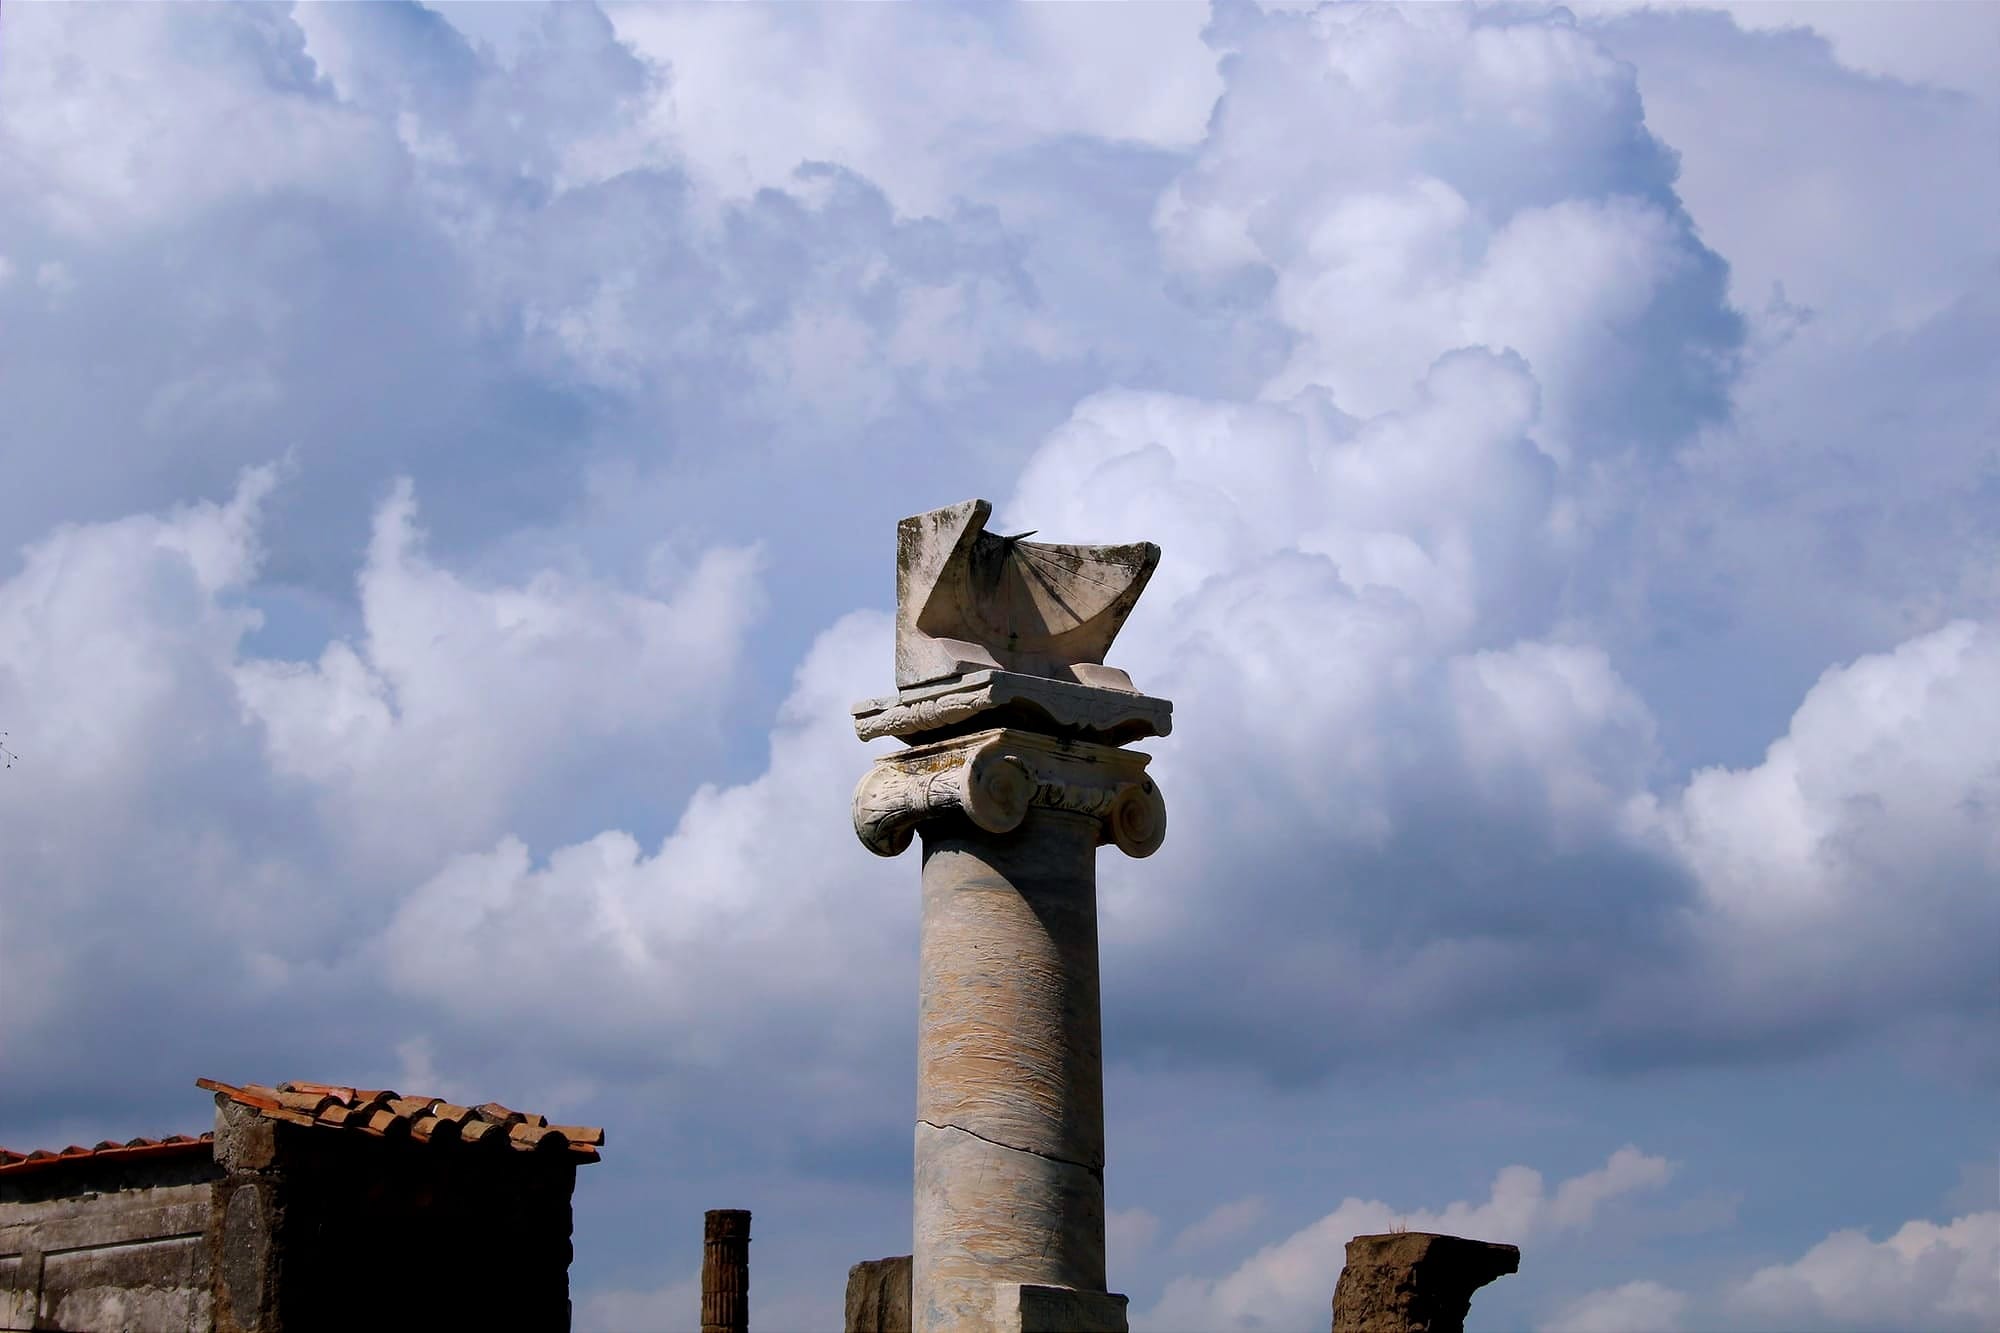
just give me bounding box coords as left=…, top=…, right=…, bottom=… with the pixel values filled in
left=1158, top=6, right=1734, bottom=452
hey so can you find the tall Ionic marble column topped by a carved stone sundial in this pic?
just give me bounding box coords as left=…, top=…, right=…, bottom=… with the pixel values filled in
left=854, top=500, right=1172, bottom=1333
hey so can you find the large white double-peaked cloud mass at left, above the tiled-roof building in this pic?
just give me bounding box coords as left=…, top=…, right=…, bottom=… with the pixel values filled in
left=0, top=468, right=758, bottom=1095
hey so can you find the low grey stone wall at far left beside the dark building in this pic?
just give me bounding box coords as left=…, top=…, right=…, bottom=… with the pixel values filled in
left=0, top=1145, right=220, bottom=1333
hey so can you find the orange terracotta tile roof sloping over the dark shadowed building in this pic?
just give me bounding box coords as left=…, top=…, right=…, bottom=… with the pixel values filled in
left=194, top=1079, right=604, bottom=1169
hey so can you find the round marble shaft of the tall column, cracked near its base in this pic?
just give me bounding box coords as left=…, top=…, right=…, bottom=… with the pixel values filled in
left=912, top=809, right=1104, bottom=1333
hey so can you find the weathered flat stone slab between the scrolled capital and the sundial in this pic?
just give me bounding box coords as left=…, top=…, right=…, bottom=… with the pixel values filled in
left=854, top=667, right=1174, bottom=745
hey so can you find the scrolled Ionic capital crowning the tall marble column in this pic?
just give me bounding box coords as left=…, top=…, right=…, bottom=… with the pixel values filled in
left=854, top=727, right=1166, bottom=857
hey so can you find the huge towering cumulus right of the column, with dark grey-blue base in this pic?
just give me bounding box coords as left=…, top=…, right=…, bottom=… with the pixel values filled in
left=976, top=0, right=1992, bottom=1075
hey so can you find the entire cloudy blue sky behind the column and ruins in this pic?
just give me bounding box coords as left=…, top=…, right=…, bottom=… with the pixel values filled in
left=0, top=0, right=2000, bottom=1333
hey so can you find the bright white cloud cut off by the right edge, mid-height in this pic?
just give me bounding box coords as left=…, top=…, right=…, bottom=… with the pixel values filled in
left=1600, top=622, right=2000, bottom=1056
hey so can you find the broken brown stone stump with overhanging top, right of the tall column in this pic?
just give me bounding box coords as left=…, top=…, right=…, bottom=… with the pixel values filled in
left=1334, top=1231, right=1520, bottom=1333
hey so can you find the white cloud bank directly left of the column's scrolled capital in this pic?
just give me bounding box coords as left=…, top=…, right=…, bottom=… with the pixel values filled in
left=380, top=612, right=914, bottom=1088
